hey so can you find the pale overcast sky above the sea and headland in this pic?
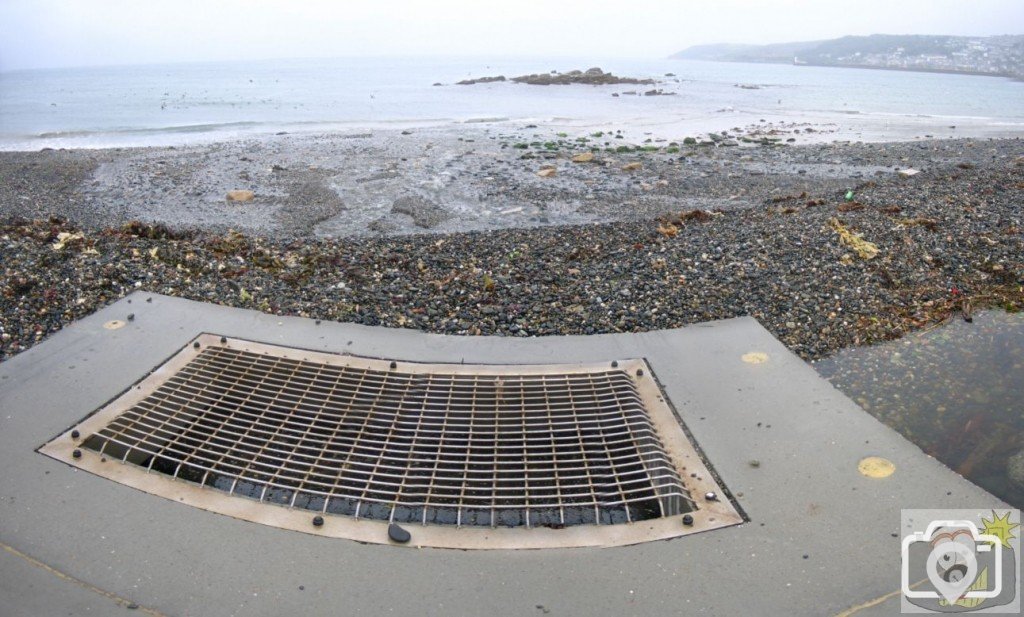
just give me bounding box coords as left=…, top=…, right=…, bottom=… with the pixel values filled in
left=0, top=0, right=1024, bottom=71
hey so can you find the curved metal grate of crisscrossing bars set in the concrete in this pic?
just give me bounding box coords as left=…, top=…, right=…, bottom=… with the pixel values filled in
left=43, top=335, right=738, bottom=547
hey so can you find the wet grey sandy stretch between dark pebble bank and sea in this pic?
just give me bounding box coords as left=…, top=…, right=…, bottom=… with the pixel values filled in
left=0, top=124, right=1022, bottom=238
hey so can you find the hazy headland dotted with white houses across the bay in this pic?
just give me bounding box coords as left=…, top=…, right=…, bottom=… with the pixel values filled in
left=670, top=35, right=1024, bottom=79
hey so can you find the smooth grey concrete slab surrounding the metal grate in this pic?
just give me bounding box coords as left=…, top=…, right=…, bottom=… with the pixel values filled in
left=0, top=293, right=1005, bottom=617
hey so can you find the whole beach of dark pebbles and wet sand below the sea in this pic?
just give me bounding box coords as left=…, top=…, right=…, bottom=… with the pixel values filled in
left=0, top=123, right=1024, bottom=359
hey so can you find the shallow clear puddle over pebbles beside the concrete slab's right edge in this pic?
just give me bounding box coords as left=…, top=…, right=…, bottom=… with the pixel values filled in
left=815, top=311, right=1024, bottom=508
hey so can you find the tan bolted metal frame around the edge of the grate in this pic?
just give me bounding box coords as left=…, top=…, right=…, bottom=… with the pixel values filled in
left=40, top=334, right=742, bottom=548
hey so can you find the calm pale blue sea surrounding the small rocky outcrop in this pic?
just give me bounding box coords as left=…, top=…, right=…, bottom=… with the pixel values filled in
left=0, top=57, right=1024, bottom=149
